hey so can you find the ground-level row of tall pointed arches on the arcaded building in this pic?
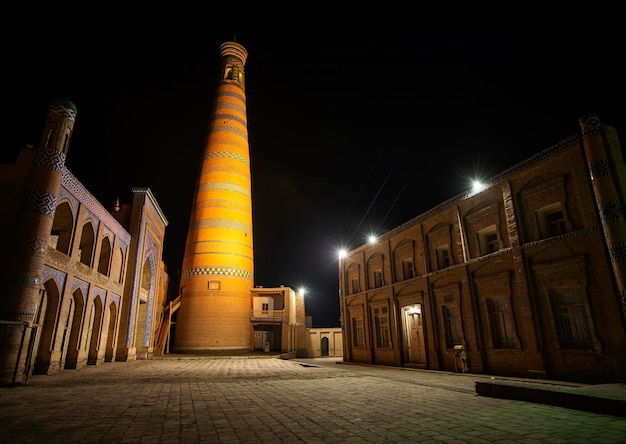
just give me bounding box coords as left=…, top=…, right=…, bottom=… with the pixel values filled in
left=27, top=253, right=154, bottom=374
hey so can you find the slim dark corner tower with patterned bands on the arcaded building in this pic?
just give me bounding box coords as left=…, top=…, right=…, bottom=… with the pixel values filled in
left=0, top=99, right=76, bottom=382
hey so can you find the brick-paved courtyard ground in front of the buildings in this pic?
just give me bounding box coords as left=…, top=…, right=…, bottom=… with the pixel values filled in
left=0, top=356, right=626, bottom=443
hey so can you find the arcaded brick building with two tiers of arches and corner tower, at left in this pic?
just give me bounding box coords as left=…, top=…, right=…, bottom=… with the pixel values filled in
left=0, top=99, right=169, bottom=383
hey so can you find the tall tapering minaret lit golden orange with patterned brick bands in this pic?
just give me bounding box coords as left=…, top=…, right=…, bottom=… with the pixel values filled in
left=173, top=42, right=254, bottom=353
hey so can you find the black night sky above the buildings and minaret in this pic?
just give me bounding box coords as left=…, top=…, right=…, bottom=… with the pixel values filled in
left=2, top=5, right=626, bottom=327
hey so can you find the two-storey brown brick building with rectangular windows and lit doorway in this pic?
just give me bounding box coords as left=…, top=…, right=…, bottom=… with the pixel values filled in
left=339, top=116, right=626, bottom=382
